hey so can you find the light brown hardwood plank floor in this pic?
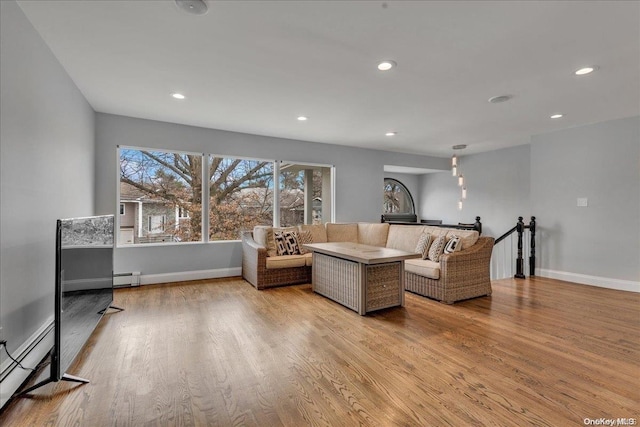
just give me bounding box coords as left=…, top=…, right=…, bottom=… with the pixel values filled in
left=0, top=278, right=640, bottom=426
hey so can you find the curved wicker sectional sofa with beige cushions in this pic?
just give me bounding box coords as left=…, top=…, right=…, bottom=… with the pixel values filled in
left=242, top=223, right=494, bottom=304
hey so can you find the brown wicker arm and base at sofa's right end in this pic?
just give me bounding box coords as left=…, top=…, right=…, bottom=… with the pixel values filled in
left=405, top=237, right=494, bottom=304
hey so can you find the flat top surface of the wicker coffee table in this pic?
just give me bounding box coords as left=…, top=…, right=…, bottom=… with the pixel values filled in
left=302, top=242, right=420, bottom=264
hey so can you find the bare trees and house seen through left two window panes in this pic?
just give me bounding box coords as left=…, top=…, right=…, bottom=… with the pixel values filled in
left=120, top=149, right=273, bottom=243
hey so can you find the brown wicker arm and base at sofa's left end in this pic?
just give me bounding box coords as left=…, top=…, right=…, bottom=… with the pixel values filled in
left=241, top=231, right=311, bottom=289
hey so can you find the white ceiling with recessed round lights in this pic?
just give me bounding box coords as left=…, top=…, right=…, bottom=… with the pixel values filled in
left=18, top=0, right=640, bottom=156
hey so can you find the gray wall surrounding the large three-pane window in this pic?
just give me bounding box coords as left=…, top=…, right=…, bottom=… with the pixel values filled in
left=96, top=114, right=448, bottom=276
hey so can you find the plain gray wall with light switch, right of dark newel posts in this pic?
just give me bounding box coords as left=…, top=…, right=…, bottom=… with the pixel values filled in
left=531, top=117, right=640, bottom=282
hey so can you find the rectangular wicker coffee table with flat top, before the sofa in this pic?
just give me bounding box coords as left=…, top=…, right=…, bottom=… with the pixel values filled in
left=304, top=242, right=420, bottom=315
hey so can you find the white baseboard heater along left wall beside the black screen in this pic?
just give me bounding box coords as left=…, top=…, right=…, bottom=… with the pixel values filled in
left=0, top=318, right=54, bottom=409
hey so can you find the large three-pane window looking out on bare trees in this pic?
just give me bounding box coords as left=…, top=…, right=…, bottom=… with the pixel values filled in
left=118, top=147, right=333, bottom=245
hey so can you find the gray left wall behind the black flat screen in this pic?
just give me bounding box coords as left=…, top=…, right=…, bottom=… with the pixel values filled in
left=0, top=1, right=95, bottom=398
